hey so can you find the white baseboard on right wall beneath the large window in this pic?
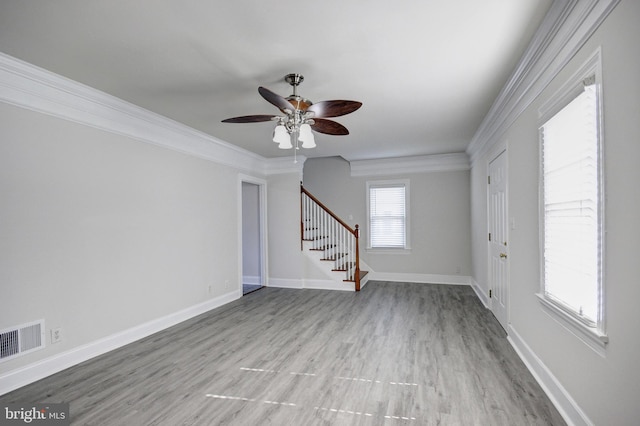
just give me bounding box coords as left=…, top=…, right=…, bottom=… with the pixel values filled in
left=507, top=325, right=593, bottom=426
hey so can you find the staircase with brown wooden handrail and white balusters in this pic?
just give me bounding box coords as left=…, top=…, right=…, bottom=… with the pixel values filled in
left=300, top=185, right=367, bottom=291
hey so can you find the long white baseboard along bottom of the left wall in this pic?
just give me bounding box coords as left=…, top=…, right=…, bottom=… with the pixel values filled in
left=0, top=290, right=242, bottom=395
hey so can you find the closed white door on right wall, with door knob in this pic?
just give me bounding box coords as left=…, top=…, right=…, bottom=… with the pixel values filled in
left=488, top=151, right=509, bottom=330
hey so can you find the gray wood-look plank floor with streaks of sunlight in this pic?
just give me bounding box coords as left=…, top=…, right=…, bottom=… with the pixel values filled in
left=0, top=281, right=565, bottom=426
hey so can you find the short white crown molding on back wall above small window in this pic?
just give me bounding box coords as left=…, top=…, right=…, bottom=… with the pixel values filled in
left=349, top=152, right=469, bottom=176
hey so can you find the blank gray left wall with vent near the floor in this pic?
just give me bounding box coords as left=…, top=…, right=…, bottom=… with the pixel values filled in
left=0, top=103, right=239, bottom=373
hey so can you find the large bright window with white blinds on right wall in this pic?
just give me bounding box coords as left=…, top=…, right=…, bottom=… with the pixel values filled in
left=539, top=52, right=606, bottom=352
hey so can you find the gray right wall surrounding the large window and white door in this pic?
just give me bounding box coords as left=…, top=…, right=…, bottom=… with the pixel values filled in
left=471, top=0, right=640, bottom=425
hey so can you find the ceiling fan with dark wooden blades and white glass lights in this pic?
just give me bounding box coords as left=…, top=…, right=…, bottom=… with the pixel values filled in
left=222, top=74, right=362, bottom=149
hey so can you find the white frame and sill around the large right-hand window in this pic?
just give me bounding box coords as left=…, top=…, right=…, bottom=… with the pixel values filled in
left=536, top=48, right=609, bottom=356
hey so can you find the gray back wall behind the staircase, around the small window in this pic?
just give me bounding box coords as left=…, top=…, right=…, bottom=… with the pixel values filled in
left=304, top=157, right=471, bottom=276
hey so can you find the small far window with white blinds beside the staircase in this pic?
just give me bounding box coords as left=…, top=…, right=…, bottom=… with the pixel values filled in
left=367, top=180, right=409, bottom=249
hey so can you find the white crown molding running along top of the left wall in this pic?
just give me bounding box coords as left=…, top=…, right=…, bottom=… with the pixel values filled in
left=0, top=52, right=267, bottom=174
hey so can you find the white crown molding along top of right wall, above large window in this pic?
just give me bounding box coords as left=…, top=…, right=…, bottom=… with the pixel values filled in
left=467, top=0, right=620, bottom=166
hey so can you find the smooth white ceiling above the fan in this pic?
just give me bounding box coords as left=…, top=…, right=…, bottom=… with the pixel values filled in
left=0, top=0, right=553, bottom=160
